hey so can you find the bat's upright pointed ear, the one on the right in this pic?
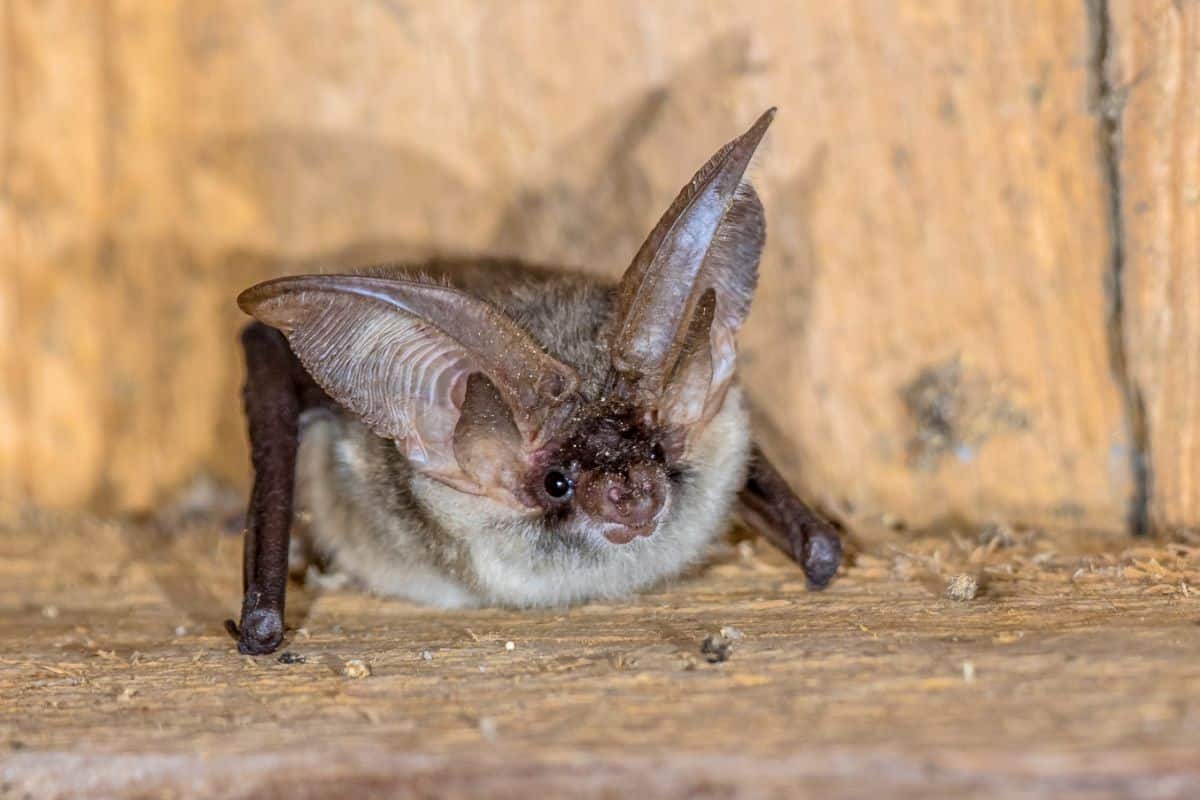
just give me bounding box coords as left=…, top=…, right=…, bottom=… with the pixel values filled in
left=610, top=108, right=775, bottom=426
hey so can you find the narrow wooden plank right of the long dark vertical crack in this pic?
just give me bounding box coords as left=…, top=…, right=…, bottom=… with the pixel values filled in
left=1108, top=0, right=1200, bottom=537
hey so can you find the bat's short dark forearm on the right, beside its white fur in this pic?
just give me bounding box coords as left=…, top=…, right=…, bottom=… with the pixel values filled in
left=738, top=445, right=841, bottom=589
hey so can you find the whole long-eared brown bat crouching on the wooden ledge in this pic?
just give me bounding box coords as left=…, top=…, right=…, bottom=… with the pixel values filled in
left=230, top=109, right=841, bottom=654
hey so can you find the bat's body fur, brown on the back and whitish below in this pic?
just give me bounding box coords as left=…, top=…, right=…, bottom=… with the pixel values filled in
left=296, top=261, right=750, bottom=607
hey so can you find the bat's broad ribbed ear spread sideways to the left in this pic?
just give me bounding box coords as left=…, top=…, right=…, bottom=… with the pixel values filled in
left=238, top=275, right=578, bottom=494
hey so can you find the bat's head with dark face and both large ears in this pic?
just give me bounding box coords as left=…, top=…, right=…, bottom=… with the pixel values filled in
left=239, top=110, right=774, bottom=566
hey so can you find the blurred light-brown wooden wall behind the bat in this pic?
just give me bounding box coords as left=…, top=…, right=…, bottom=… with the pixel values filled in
left=0, top=0, right=1200, bottom=531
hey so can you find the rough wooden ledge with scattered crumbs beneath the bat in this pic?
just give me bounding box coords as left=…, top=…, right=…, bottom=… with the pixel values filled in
left=0, top=518, right=1200, bottom=798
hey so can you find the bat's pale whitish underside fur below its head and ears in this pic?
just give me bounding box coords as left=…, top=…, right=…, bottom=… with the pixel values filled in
left=296, top=386, right=750, bottom=608
